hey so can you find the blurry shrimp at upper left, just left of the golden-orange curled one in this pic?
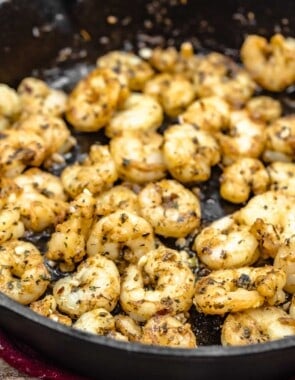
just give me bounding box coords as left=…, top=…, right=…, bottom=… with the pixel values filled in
left=17, top=77, right=67, bottom=116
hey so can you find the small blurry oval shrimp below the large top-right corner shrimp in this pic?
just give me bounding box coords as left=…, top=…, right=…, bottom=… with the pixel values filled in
left=245, top=95, right=283, bottom=122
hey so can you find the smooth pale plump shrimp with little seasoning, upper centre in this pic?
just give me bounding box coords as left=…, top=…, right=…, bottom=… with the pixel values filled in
left=105, top=93, right=163, bottom=138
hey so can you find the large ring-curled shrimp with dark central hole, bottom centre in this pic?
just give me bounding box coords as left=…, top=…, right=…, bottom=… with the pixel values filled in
left=120, top=246, right=195, bottom=321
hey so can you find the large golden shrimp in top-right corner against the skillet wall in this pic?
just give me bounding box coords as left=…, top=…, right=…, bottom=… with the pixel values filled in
left=240, top=33, right=295, bottom=92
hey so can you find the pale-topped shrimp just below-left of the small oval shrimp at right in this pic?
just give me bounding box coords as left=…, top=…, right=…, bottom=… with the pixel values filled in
left=216, top=110, right=266, bottom=165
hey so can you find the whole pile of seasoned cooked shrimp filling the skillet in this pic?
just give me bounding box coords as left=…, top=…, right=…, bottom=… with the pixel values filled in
left=0, top=34, right=295, bottom=349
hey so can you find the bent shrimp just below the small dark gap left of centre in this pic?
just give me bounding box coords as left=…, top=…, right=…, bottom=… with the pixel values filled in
left=61, top=144, right=118, bottom=198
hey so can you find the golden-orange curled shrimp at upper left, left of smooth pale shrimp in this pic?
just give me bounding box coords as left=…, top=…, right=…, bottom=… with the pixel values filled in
left=65, top=68, right=129, bottom=132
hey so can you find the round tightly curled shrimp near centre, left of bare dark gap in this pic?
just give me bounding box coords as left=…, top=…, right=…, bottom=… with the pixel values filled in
left=138, top=179, right=201, bottom=238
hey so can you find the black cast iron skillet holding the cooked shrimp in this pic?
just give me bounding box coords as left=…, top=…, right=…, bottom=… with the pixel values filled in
left=0, top=0, right=295, bottom=380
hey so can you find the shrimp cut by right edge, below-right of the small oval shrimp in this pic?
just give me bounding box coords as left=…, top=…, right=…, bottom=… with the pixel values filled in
left=263, top=114, right=295, bottom=162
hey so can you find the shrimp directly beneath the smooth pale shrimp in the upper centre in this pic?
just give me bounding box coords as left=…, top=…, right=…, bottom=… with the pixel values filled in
left=110, top=131, right=166, bottom=184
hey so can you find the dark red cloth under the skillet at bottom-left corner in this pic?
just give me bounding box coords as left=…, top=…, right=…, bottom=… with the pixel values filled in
left=0, top=330, right=87, bottom=380
